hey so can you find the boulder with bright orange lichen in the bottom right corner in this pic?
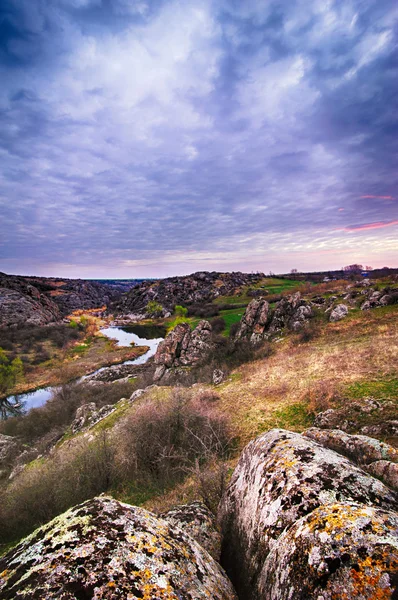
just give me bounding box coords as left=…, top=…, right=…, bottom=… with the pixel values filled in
left=256, top=504, right=398, bottom=600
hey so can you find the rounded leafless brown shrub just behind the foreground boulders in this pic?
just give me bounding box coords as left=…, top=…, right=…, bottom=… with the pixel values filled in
left=118, top=389, right=231, bottom=487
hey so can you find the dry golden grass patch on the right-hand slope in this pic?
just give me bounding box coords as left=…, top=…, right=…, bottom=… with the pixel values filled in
left=210, top=307, right=398, bottom=445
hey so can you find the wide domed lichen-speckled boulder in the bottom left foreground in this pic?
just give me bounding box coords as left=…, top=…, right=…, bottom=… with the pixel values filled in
left=0, top=497, right=236, bottom=600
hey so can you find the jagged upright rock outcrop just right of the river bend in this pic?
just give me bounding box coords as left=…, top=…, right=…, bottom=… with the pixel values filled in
left=154, top=321, right=213, bottom=381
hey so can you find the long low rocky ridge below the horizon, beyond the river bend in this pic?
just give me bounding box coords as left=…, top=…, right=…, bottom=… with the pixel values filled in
left=112, top=271, right=264, bottom=314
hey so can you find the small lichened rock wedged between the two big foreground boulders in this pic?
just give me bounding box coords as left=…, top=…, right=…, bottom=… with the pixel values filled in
left=160, top=502, right=221, bottom=561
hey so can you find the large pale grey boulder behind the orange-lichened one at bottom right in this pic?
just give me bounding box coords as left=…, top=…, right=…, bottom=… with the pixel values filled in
left=220, top=430, right=398, bottom=600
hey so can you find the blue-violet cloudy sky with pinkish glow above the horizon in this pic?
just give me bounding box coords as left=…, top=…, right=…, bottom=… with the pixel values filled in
left=0, top=0, right=398, bottom=277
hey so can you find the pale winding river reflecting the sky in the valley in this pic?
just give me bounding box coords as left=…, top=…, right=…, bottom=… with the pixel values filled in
left=7, top=325, right=165, bottom=412
